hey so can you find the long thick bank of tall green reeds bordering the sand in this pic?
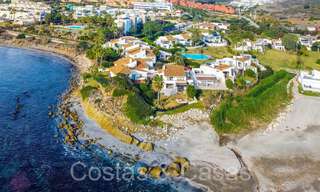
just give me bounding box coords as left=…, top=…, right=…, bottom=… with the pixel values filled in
left=211, top=71, right=293, bottom=133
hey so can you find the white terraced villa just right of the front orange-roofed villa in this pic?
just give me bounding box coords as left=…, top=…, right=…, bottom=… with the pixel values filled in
left=190, top=65, right=227, bottom=90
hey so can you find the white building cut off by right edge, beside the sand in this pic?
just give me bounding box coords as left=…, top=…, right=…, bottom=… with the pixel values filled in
left=299, top=70, right=320, bottom=92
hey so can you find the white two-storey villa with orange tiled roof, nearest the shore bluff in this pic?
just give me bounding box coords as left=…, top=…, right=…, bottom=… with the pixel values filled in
left=161, top=64, right=187, bottom=96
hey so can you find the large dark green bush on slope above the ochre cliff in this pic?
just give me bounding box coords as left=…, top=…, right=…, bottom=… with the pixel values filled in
left=125, top=93, right=154, bottom=123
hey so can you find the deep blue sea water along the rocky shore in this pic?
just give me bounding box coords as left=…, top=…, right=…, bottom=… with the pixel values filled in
left=0, top=47, right=200, bottom=192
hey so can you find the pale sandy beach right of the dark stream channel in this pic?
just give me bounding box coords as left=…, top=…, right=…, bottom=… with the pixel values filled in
left=235, top=79, right=320, bottom=191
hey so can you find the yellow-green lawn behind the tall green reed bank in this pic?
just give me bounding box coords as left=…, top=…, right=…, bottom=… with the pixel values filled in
left=257, top=50, right=320, bottom=70
